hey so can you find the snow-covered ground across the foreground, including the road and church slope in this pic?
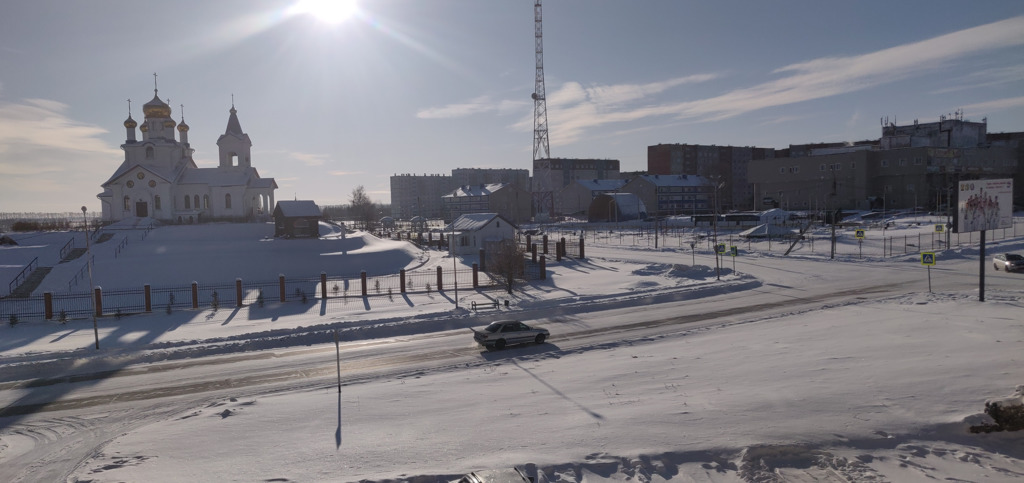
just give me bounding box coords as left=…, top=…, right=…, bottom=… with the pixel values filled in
left=0, top=218, right=1024, bottom=482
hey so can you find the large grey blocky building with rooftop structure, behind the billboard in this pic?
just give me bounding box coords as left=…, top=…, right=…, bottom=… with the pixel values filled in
left=751, top=118, right=1021, bottom=211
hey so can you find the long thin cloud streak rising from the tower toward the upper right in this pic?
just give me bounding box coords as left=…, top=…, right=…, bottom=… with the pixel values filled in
left=536, top=16, right=1024, bottom=143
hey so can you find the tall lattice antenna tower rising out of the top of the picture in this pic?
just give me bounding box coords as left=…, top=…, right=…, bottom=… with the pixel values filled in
left=532, top=0, right=555, bottom=217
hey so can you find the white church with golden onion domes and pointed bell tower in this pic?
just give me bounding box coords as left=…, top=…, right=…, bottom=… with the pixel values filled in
left=96, top=85, right=278, bottom=223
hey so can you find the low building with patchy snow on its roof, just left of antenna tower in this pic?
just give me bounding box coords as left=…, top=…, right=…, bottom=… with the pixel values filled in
left=441, top=183, right=532, bottom=223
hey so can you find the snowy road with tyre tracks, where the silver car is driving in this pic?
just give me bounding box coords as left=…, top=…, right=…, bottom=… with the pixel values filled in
left=0, top=248, right=1022, bottom=482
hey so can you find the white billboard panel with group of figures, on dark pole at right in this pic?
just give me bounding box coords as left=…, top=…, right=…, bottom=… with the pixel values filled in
left=956, top=179, right=1014, bottom=233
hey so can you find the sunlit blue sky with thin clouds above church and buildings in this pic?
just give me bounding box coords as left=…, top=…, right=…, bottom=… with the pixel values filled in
left=0, top=0, right=1024, bottom=212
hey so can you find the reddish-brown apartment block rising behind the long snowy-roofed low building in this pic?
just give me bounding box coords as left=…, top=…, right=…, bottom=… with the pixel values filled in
left=647, top=144, right=776, bottom=211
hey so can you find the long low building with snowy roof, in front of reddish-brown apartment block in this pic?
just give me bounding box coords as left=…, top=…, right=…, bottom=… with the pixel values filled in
left=622, top=174, right=712, bottom=215
